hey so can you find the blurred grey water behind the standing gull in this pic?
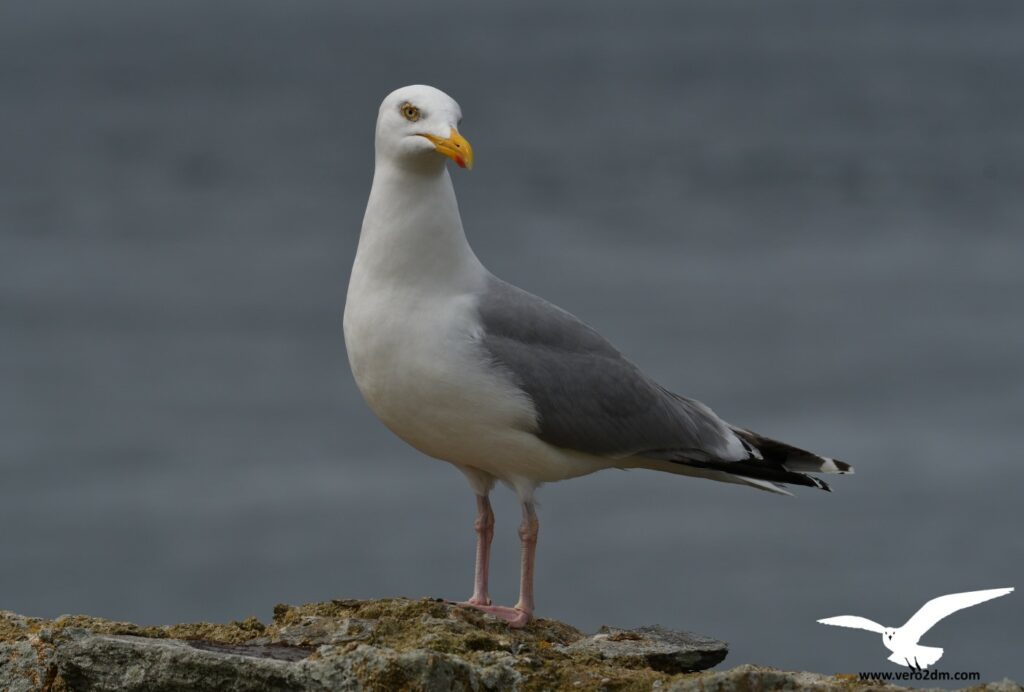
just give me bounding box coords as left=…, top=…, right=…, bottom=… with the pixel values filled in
left=0, top=0, right=1024, bottom=680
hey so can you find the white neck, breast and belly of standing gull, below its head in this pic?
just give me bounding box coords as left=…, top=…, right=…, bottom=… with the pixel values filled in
left=345, top=159, right=611, bottom=491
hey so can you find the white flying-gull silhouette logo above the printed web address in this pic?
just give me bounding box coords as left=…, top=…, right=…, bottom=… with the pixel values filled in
left=818, top=588, right=1013, bottom=671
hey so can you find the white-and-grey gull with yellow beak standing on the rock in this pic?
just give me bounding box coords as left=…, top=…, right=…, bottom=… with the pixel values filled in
left=344, top=85, right=853, bottom=628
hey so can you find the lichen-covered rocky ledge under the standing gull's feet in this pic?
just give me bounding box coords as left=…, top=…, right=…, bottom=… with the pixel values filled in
left=0, top=599, right=1024, bottom=692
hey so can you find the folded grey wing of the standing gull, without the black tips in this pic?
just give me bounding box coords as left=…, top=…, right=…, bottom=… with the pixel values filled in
left=478, top=277, right=750, bottom=463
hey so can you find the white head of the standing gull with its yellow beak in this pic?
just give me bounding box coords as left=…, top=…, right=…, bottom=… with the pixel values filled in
left=376, top=84, right=473, bottom=170
